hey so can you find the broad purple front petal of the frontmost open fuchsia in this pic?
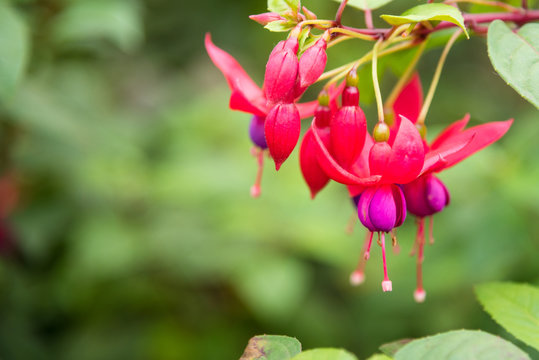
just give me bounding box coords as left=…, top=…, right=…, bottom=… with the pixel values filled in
left=370, top=185, right=397, bottom=232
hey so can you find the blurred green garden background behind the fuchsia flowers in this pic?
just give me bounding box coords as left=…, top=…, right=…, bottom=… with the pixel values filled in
left=0, top=0, right=539, bottom=360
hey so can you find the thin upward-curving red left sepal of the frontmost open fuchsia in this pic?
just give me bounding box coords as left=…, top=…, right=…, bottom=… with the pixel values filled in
left=311, top=121, right=381, bottom=185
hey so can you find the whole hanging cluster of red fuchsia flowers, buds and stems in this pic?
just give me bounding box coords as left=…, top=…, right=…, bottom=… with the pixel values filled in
left=206, top=0, right=539, bottom=302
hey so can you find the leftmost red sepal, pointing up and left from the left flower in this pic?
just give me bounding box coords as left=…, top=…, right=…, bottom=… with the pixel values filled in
left=205, top=33, right=268, bottom=116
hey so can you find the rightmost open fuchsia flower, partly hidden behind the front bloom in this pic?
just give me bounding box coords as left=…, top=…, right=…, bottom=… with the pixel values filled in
left=393, top=74, right=513, bottom=302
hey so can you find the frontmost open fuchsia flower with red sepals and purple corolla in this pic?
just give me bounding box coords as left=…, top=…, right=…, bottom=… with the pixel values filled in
left=311, top=91, right=472, bottom=291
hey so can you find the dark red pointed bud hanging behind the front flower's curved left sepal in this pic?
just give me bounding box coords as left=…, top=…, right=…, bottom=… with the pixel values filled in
left=299, top=128, right=329, bottom=199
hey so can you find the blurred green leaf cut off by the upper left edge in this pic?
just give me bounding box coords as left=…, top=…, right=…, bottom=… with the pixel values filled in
left=0, top=1, right=28, bottom=102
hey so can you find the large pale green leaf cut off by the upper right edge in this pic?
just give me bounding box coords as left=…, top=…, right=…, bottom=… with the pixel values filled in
left=487, top=20, right=539, bottom=108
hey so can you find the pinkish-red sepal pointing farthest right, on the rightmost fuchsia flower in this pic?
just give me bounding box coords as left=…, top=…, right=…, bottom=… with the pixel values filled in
left=437, top=119, right=513, bottom=171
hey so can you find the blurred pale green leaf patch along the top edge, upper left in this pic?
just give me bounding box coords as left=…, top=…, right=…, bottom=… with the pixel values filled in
left=53, top=0, right=143, bottom=51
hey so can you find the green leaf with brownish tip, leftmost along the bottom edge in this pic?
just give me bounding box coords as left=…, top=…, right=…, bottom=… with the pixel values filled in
left=240, top=335, right=301, bottom=360
